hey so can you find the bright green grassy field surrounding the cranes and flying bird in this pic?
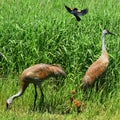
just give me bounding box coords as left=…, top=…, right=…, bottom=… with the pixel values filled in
left=0, top=0, right=120, bottom=120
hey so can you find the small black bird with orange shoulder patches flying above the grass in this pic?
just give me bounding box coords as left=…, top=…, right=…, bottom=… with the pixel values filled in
left=65, top=5, right=88, bottom=21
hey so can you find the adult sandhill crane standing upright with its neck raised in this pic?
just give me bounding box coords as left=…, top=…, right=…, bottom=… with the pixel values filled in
left=82, top=30, right=114, bottom=90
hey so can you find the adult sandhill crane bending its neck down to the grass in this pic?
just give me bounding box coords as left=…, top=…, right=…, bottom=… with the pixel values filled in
left=6, top=64, right=66, bottom=108
